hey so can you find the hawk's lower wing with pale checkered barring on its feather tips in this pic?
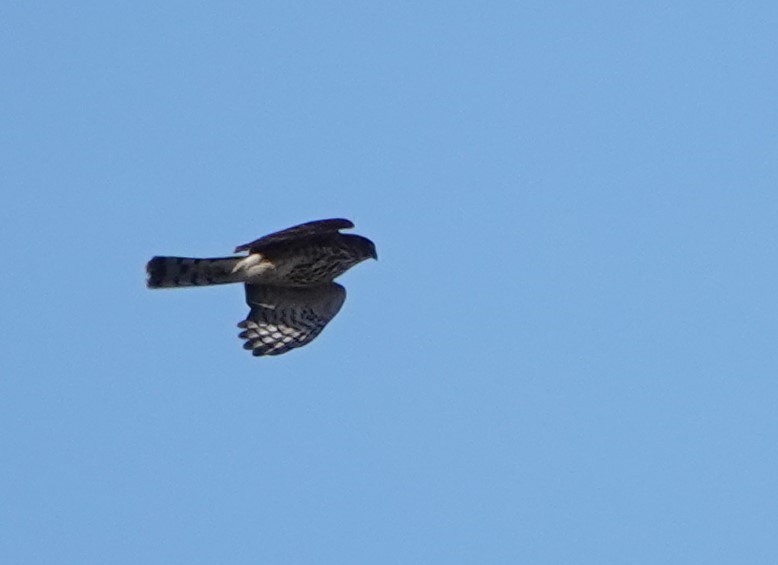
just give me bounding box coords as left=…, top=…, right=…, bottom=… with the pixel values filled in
left=238, top=283, right=346, bottom=356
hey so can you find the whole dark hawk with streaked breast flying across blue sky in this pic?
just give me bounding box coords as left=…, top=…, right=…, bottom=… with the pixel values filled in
left=146, top=219, right=378, bottom=356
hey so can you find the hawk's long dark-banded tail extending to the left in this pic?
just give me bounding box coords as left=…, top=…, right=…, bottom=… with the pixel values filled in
left=146, top=257, right=245, bottom=288
